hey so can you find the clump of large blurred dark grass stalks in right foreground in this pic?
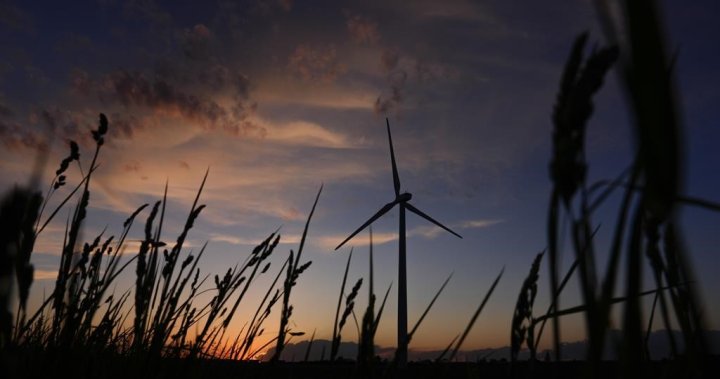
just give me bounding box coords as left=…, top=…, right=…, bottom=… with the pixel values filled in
left=548, top=0, right=712, bottom=377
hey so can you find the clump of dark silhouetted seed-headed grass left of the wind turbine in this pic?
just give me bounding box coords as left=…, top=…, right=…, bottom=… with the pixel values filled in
left=0, top=114, right=320, bottom=378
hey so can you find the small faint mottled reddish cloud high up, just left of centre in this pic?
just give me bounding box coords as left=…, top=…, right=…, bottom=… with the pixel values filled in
left=288, top=44, right=346, bottom=82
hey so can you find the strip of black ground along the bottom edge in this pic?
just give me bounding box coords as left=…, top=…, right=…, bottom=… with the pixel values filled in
left=0, top=351, right=720, bottom=379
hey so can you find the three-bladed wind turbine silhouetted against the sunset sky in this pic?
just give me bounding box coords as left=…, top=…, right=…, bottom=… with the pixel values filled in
left=335, top=118, right=462, bottom=367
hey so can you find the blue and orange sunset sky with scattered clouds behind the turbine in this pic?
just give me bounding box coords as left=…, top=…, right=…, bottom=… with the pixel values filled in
left=0, top=0, right=720, bottom=356
